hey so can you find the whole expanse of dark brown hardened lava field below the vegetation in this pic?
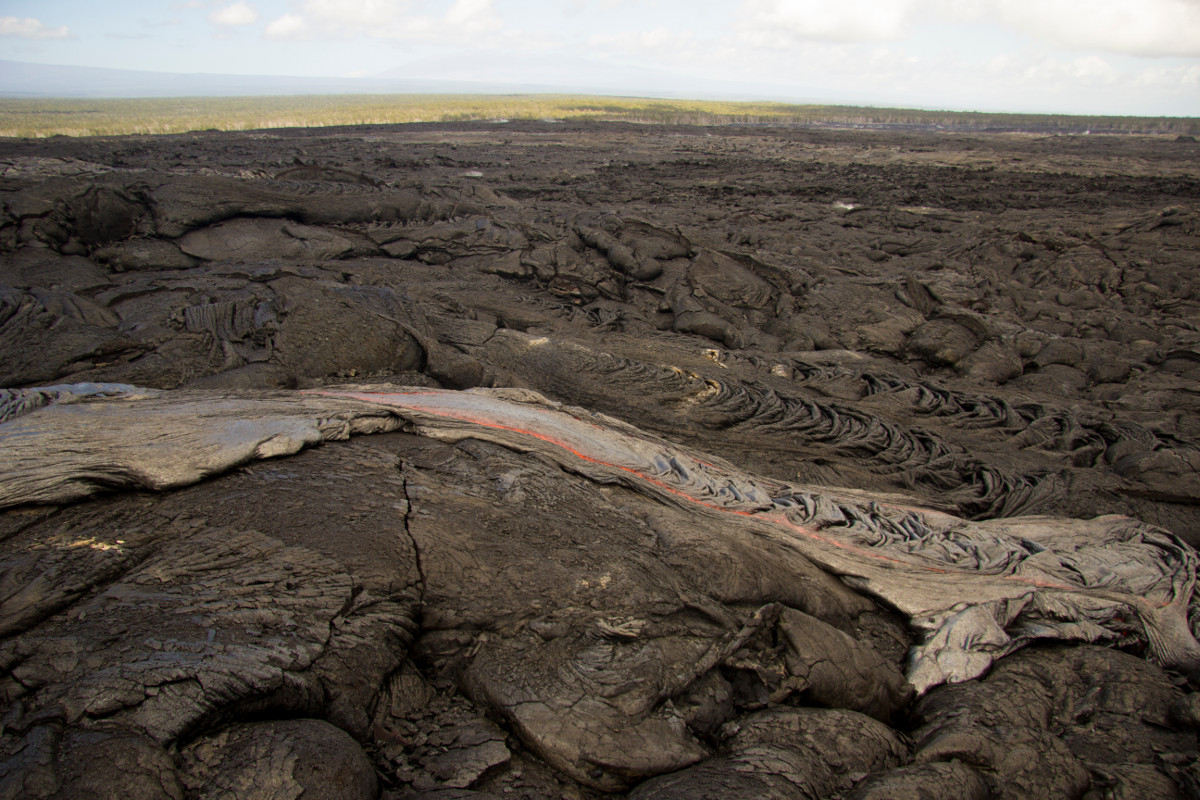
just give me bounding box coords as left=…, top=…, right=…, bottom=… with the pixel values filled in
left=0, top=122, right=1200, bottom=800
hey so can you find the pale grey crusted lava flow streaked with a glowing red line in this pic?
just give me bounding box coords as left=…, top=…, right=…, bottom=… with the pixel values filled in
left=0, top=384, right=1200, bottom=692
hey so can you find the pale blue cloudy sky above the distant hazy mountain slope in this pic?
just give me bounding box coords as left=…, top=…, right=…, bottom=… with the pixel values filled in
left=0, top=0, right=1200, bottom=116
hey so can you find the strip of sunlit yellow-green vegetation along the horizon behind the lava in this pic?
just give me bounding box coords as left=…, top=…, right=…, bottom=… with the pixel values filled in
left=0, top=95, right=1200, bottom=137
